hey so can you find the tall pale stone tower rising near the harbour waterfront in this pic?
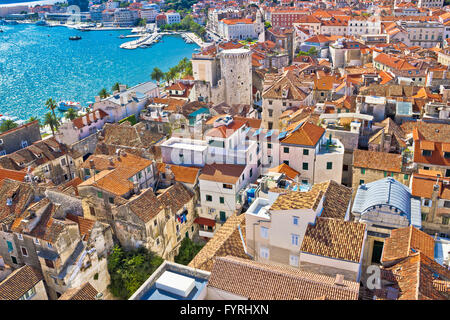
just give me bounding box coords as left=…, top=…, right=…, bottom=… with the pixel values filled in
left=220, top=48, right=253, bottom=106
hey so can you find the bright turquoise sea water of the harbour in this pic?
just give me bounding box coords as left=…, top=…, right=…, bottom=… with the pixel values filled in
left=0, top=25, right=198, bottom=120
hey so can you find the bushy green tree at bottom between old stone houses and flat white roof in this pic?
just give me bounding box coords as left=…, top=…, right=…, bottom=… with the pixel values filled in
left=108, top=245, right=164, bottom=299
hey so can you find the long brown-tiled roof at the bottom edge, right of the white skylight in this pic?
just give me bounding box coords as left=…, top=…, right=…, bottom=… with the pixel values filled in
left=208, top=256, right=359, bottom=300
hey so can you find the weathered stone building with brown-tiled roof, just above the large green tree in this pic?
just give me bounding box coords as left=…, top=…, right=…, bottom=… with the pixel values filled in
left=111, top=183, right=196, bottom=261
